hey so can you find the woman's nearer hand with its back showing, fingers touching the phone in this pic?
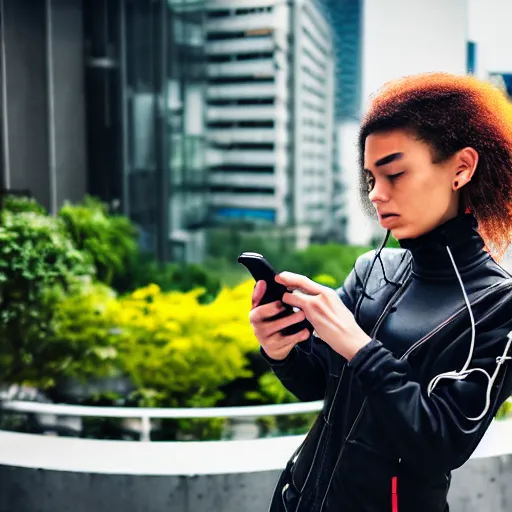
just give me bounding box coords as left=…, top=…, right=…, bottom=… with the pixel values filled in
left=275, top=272, right=371, bottom=361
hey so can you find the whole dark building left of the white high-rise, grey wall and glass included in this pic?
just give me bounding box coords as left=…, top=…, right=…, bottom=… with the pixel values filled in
left=0, top=0, right=208, bottom=261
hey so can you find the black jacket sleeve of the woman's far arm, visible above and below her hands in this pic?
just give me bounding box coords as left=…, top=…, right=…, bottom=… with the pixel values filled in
left=260, top=251, right=373, bottom=402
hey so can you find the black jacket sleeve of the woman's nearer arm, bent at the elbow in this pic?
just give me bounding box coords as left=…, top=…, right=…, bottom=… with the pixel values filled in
left=347, top=305, right=512, bottom=473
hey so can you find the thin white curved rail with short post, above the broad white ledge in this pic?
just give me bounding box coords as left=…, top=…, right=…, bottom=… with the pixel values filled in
left=0, top=400, right=323, bottom=441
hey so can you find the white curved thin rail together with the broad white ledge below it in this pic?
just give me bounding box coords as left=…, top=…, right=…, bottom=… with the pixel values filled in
left=0, top=401, right=512, bottom=475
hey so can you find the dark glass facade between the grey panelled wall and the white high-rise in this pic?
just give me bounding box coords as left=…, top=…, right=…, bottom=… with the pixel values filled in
left=85, top=0, right=207, bottom=260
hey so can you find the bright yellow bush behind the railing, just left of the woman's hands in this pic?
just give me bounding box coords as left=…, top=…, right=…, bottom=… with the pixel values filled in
left=111, top=282, right=258, bottom=407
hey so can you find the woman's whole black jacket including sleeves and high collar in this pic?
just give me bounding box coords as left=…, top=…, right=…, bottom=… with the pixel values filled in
left=262, top=215, right=512, bottom=512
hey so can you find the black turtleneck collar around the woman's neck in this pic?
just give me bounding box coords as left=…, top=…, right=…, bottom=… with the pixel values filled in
left=399, top=214, right=489, bottom=278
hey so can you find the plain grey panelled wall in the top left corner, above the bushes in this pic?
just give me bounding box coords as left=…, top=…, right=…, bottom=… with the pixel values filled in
left=0, top=0, right=86, bottom=211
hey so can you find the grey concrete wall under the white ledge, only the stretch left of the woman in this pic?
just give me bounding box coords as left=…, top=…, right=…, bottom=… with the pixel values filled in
left=0, top=466, right=278, bottom=512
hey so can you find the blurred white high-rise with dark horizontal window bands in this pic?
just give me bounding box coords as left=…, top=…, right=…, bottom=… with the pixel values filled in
left=206, top=0, right=334, bottom=245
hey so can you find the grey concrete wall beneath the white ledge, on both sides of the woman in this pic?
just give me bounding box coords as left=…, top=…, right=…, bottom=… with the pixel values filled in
left=0, top=455, right=512, bottom=512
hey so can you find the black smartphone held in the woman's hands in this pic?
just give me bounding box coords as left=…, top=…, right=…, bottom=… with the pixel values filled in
left=238, top=252, right=313, bottom=336
